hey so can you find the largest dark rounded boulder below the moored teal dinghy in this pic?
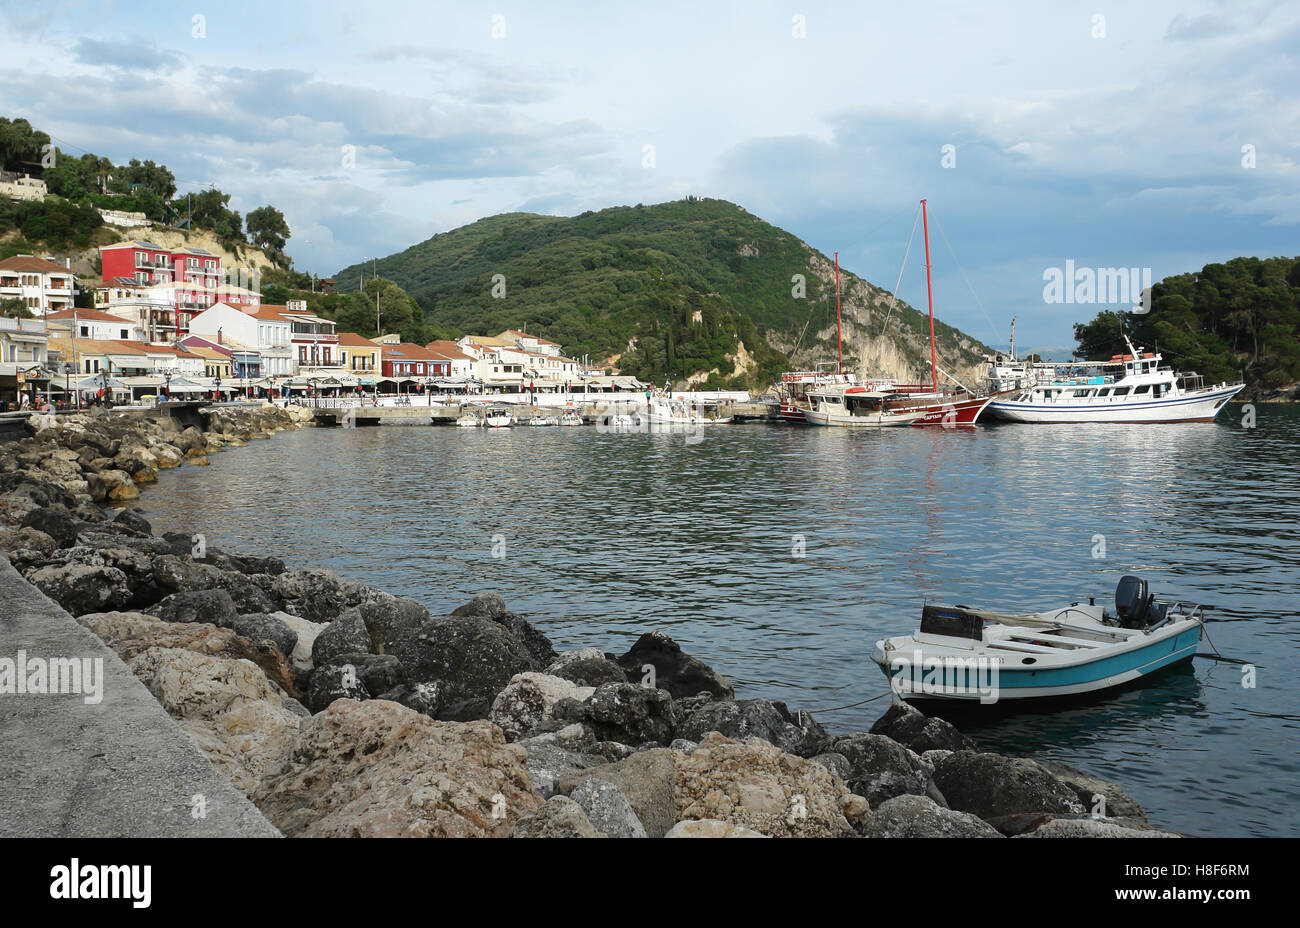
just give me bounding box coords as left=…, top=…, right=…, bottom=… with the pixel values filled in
left=935, top=751, right=1087, bottom=819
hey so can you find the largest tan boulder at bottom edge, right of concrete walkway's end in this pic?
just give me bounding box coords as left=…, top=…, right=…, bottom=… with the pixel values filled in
left=252, top=699, right=542, bottom=837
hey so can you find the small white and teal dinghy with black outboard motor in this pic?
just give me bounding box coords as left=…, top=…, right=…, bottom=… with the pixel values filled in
left=871, top=576, right=1205, bottom=703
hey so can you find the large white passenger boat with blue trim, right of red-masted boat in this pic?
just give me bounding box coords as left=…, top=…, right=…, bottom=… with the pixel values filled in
left=988, top=337, right=1245, bottom=422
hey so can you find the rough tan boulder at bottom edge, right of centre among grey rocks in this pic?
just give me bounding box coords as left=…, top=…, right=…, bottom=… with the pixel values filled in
left=671, top=732, right=866, bottom=837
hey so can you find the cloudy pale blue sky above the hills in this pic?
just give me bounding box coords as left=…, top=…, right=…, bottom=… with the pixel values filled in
left=0, top=0, right=1300, bottom=354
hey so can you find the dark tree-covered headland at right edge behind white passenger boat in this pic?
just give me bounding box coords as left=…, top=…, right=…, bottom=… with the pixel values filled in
left=1074, top=257, right=1300, bottom=399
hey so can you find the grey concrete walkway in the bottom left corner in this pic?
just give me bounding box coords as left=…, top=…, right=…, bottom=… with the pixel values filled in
left=0, top=554, right=280, bottom=837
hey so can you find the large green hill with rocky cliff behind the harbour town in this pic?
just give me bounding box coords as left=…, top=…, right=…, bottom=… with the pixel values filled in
left=335, top=198, right=987, bottom=389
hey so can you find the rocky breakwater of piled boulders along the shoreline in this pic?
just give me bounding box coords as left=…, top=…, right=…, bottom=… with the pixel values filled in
left=0, top=400, right=1167, bottom=837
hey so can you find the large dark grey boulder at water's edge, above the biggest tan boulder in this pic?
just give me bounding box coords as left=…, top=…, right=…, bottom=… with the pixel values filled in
left=391, top=616, right=533, bottom=720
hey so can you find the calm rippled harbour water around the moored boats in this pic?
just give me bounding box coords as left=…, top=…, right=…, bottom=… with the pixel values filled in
left=140, top=407, right=1300, bottom=834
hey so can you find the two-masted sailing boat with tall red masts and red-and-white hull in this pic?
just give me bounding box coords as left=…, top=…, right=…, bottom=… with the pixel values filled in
left=800, top=200, right=1011, bottom=428
